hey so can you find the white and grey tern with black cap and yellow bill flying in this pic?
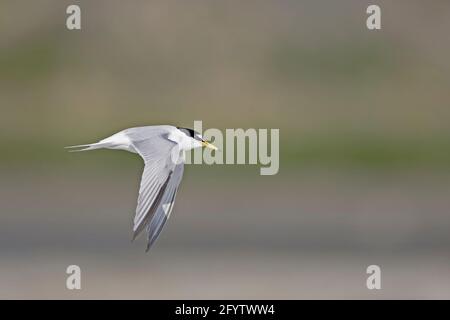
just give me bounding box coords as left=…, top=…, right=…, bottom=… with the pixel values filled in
left=66, top=125, right=218, bottom=251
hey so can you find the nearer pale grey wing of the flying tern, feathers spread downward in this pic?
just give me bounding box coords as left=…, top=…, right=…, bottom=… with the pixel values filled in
left=132, top=134, right=184, bottom=242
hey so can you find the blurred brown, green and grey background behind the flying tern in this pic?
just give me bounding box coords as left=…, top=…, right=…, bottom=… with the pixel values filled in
left=0, top=0, right=450, bottom=299
